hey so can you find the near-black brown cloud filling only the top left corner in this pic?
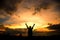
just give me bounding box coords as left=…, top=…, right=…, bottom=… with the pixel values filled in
left=0, top=0, right=22, bottom=14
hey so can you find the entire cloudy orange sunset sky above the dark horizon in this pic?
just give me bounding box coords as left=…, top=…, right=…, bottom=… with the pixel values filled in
left=0, top=0, right=60, bottom=29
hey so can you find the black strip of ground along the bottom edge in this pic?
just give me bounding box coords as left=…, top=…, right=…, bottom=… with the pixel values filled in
left=0, top=35, right=60, bottom=40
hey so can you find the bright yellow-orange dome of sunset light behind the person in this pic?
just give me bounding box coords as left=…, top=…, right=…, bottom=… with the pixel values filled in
left=5, top=13, right=49, bottom=29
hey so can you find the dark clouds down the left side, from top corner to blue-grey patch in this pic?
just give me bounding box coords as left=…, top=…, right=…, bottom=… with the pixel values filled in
left=0, top=0, right=22, bottom=23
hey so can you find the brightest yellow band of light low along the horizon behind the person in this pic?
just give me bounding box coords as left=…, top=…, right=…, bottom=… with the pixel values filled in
left=5, top=22, right=49, bottom=29
